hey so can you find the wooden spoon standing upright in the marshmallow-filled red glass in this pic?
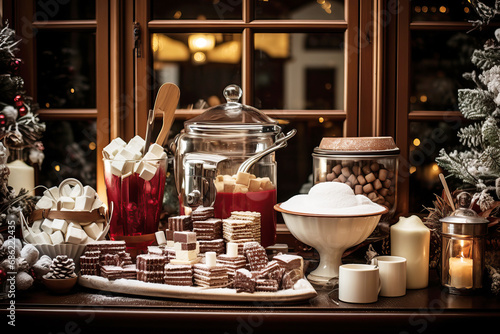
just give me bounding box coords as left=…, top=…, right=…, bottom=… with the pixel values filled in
left=154, top=82, right=181, bottom=146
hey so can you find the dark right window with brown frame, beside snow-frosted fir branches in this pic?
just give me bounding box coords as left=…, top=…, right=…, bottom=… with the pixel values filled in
left=395, top=0, right=494, bottom=213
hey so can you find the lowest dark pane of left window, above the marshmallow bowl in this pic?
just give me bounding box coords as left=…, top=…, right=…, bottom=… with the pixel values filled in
left=39, top=121, right=97, bottom=189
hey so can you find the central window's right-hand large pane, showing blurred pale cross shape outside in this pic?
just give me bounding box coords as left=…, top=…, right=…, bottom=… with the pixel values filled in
left=254, top=33, right=344, bottom=110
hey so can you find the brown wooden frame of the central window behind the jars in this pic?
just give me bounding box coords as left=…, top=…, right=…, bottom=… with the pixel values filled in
left=131, top=0, right=362, bottom=140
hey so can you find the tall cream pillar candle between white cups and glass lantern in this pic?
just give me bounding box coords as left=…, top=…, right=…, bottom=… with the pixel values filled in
left=390, top=216, right=431, bottom=289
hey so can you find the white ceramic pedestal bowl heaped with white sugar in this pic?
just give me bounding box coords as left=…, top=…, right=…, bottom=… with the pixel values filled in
left=274, top=203, right=388, bottom=284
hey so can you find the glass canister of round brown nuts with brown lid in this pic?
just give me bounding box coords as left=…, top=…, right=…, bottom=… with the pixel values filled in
left=312, top=137, right=399, bottom=219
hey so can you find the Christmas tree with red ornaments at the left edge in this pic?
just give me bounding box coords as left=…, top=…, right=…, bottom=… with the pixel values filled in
left=0, top=26, right=45, bottom=228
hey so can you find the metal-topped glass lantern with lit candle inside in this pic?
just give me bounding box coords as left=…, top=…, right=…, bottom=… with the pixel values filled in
left=440, top=216, right=488, bottom=294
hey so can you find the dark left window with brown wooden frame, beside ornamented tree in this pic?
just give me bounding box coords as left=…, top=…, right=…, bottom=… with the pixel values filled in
left=3, top=1, right=109, bottom=197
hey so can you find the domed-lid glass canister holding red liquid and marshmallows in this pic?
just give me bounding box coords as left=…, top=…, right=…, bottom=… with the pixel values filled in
left=173, top=85, right=294, bottom=247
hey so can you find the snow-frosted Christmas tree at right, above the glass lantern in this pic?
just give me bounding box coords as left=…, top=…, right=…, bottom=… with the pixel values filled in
left=436, top=21, right=500, bottom=211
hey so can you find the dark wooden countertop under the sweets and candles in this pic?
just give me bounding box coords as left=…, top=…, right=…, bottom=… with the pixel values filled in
left=0, top=272, right=500, bottom=334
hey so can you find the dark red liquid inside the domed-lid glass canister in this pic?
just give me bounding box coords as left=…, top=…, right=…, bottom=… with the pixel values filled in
left=214, top=189, right=276, bottom=247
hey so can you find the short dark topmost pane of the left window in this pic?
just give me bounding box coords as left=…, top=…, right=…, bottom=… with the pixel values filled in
left=34, top=0, right=95, bottom=21
